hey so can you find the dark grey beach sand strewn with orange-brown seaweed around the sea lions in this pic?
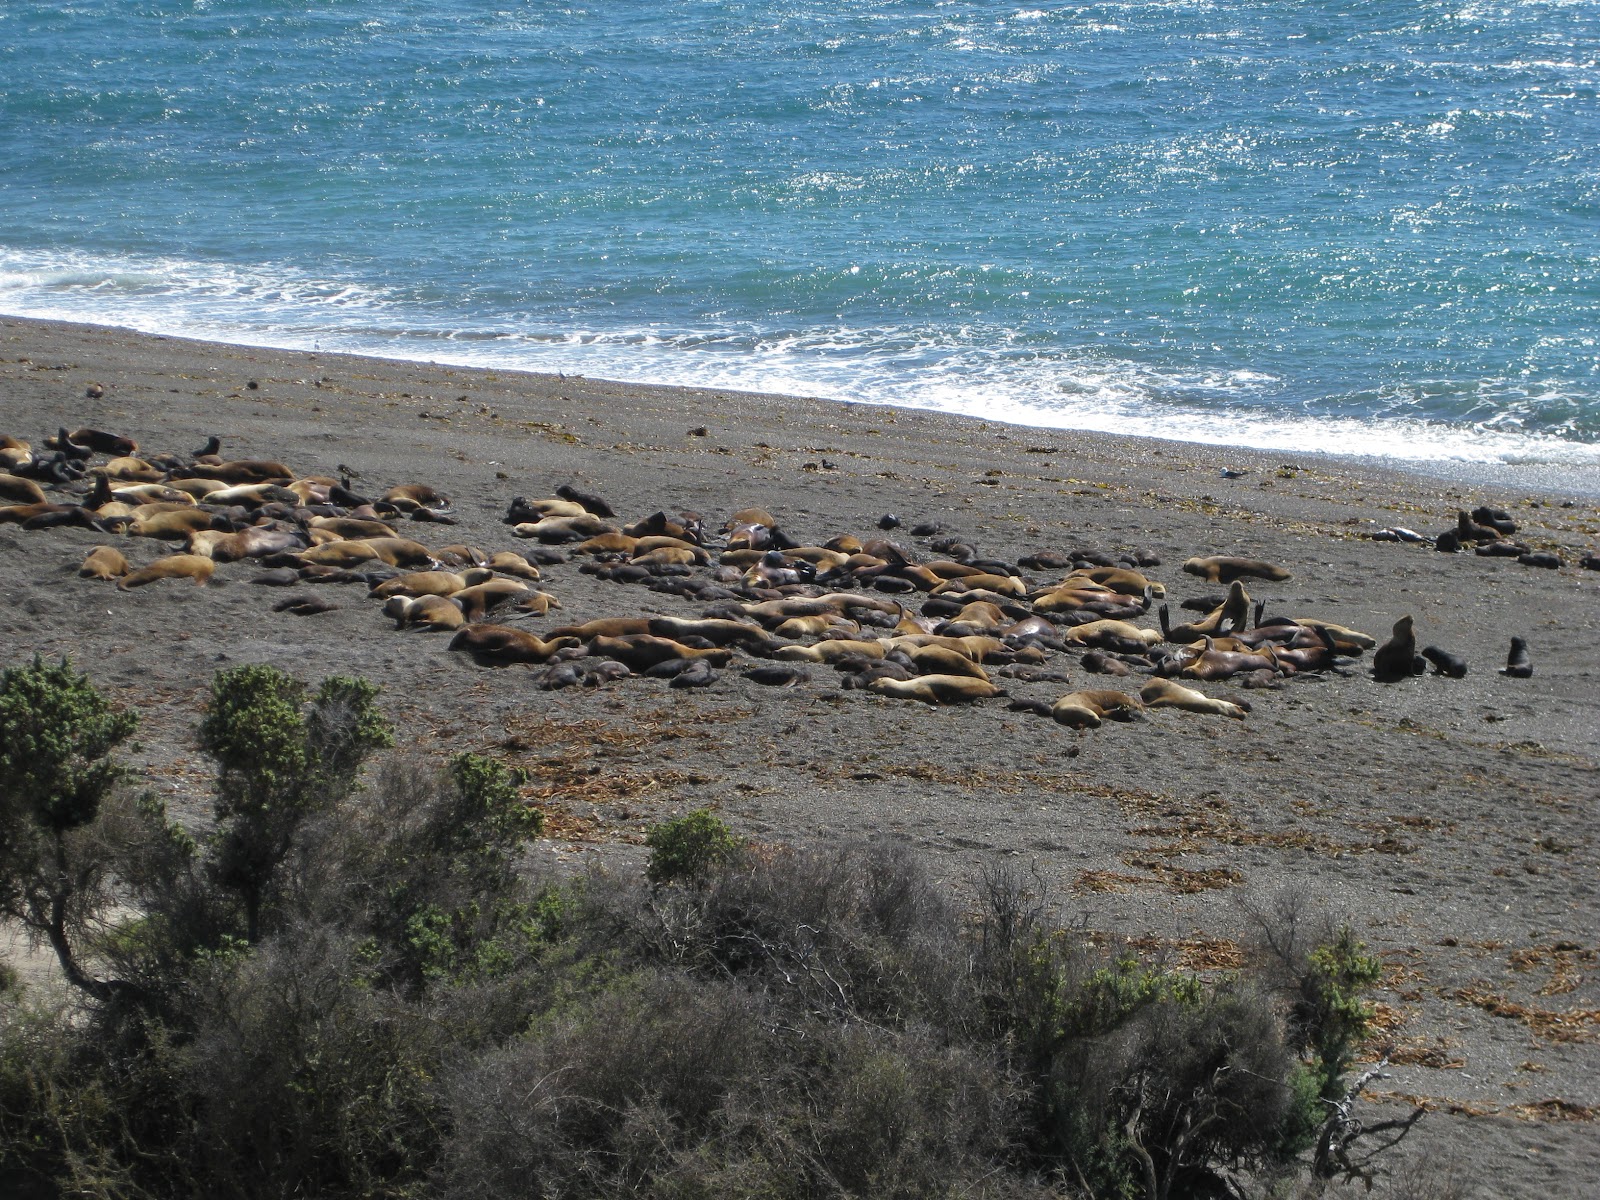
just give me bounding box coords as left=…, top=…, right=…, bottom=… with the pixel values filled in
left=0, top=318, right=1600, bottom=1200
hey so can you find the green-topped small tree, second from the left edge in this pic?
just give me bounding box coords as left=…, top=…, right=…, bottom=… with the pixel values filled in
left=200, top=666, right=394, bottom=942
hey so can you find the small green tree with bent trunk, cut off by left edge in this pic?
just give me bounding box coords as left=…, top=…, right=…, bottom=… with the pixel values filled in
left=0, top=654, right=139, bottom=1000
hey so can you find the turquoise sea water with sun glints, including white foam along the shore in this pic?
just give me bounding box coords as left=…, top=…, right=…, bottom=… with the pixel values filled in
left=0, top=0, right=1600, bottom=467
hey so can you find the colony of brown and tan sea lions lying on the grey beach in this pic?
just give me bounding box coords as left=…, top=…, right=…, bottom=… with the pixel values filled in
left=0, top=429, right=1587, bottom=728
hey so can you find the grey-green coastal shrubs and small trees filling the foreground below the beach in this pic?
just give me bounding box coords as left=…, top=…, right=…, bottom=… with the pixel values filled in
left=0, top=659, right=1427, bottom=1200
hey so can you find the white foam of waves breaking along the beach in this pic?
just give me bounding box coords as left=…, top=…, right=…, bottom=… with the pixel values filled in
left=0, top=248, right=1600, bottom=467
